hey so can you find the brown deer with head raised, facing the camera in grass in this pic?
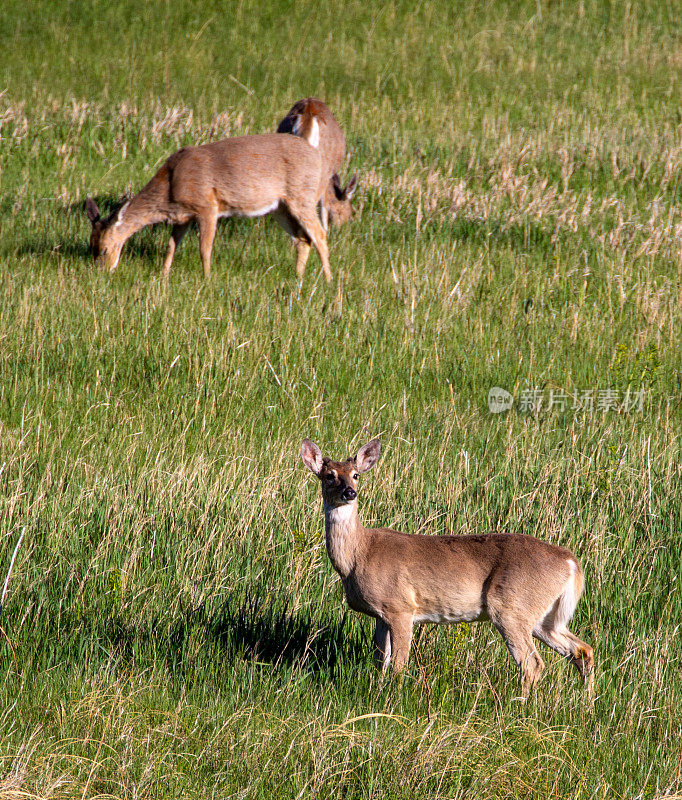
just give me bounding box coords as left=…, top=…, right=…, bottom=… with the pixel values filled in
left=301, top=439, right=594, bottom=700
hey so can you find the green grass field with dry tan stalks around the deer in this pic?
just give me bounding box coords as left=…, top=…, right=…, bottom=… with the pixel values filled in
left=0, top=0, right=682, bottom=800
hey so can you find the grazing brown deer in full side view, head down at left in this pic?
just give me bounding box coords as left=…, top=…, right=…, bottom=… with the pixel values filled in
left=86, top=133, right=352, bottom=282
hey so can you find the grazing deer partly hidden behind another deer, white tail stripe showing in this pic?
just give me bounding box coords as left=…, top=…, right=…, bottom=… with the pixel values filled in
left=277, top=97, right=358, bottom=229
